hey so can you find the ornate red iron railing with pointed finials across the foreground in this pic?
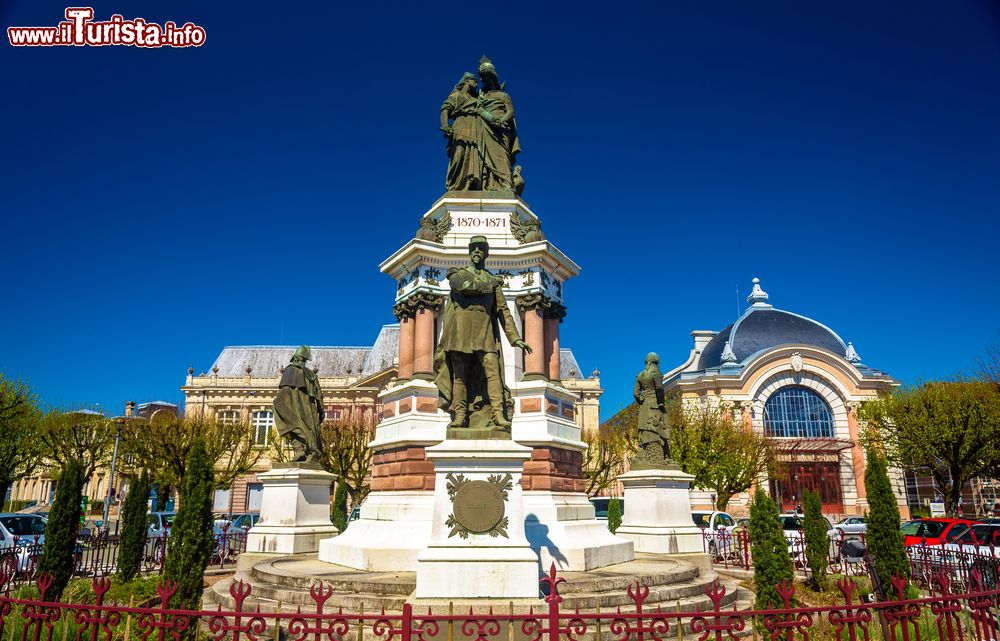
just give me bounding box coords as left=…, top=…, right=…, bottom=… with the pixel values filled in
left=0, top=565, right=1000, bottom=641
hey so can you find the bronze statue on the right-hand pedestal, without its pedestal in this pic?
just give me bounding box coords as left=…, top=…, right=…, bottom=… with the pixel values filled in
left=632, top=352, right=672, bottom=470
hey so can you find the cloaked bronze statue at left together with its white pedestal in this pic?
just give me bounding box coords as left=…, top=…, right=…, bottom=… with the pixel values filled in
left=247, top=345, right=337, bottom=554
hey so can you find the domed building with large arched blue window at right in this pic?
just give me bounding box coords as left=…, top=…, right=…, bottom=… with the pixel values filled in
left=664, top=278, right=906, bottom=515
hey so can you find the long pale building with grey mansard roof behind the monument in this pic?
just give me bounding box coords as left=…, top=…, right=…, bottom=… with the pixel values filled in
left=181, top=324, right=603, bottom=512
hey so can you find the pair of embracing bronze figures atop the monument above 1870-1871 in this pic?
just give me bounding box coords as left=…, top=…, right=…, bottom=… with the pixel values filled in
left=441, top=56, right=524, bottom=196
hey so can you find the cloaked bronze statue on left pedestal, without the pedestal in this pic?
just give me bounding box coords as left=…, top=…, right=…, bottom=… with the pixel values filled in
left=274, top=345, right=323, bottom=463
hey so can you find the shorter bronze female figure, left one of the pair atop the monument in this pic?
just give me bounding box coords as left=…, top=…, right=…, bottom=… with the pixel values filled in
left=441, top=72, right=483, bottom=191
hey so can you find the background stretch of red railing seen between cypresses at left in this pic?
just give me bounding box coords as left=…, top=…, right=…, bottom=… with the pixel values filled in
left=0, top=528, right=247, bottom=589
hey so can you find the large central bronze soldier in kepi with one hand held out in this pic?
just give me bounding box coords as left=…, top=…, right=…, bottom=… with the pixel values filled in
left=435, top=236, right=532, bottom=430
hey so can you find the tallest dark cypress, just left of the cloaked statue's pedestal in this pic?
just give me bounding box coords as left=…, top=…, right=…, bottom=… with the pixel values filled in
left=163, top=437, right=215, bottom=610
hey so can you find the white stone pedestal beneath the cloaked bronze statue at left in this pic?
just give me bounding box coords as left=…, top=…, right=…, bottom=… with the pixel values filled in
left=247, top=464, right=337, bottom=554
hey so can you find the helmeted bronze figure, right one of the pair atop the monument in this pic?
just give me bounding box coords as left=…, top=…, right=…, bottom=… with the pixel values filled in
left=479, top=56, right=521, bottom=191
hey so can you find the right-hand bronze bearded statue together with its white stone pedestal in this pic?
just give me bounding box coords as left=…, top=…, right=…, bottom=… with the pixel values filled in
left=615, top=352, right=704, bottom=554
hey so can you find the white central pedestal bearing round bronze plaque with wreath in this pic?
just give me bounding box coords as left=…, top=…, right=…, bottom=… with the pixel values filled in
left=416, top=440, right=539, bottom=599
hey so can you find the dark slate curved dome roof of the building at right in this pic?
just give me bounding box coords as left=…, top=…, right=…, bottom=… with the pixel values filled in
left=698, top=306, right=847, bottom=370
